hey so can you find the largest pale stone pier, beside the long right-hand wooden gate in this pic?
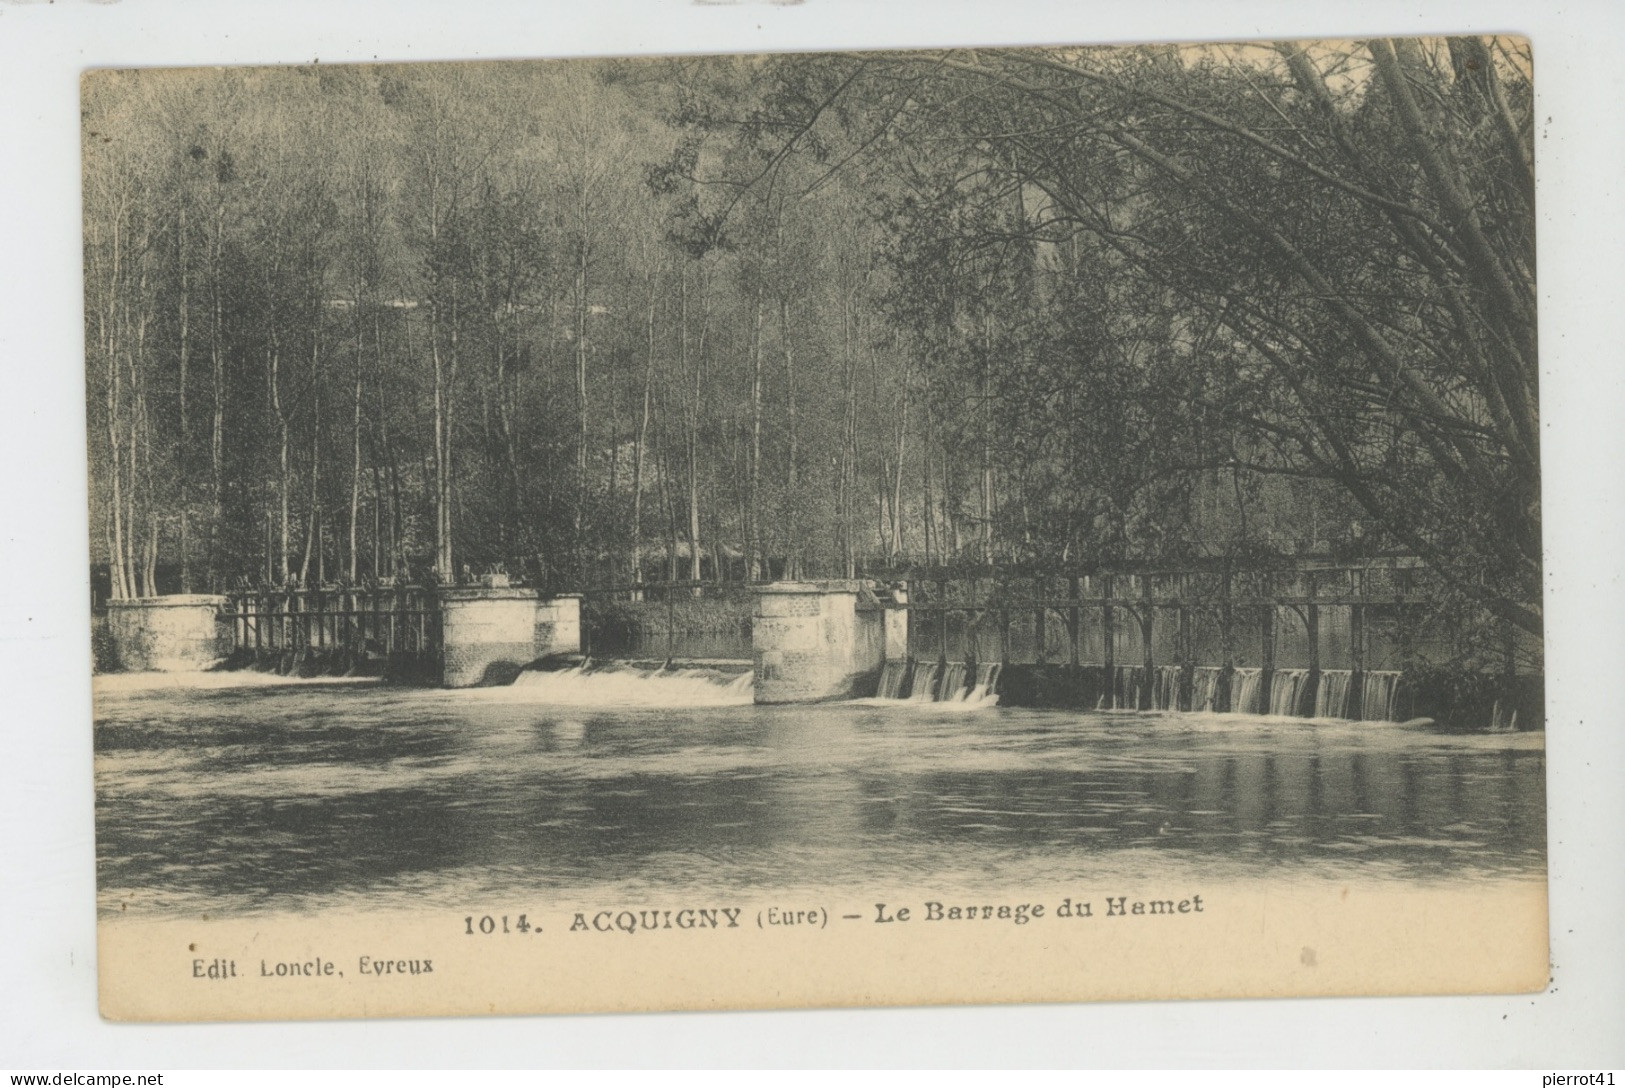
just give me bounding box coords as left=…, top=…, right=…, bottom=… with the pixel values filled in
left=751, top=581, right=887, bottom=703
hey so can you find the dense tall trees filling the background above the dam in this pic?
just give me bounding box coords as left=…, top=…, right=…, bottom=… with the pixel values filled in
left=85, top=39, right=1541, bottom=632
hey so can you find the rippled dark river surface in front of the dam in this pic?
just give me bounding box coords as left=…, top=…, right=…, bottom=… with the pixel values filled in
left=96, top=677, right=1545, bottom=913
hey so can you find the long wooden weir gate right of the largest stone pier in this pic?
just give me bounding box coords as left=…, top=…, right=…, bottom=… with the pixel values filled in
left=879, top=557, right=1544, bottom=727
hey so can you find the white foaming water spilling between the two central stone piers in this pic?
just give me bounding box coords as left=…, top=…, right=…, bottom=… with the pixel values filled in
left=476, top=666, right=756, bottom=706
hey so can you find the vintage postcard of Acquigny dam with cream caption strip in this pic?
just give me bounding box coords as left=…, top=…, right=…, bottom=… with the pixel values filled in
left=83, top=37, right=1547, bottom=1020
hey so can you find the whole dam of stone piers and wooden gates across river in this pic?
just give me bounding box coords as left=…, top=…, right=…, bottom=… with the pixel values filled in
left=95, top=557, right=1544, bottom=729
